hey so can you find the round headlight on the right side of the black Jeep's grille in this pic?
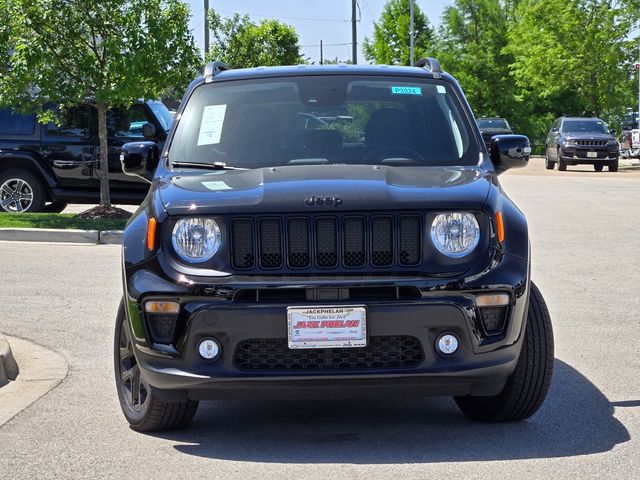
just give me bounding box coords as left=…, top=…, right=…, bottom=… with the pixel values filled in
left=431, top=212, right=480, bottom=258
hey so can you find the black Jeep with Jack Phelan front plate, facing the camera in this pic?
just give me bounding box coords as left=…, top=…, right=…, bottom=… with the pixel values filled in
left=114, top=59, right=553, bottom=431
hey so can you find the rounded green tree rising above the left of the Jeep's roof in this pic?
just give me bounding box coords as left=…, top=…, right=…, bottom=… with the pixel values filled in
left=207, top=9, right=302, bottom=68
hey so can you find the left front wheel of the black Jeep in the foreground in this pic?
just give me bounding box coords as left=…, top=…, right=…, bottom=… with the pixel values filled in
left=113, top=302, right=198, bottom=432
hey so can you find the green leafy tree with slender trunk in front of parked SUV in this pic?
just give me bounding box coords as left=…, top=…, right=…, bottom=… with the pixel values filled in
left=0, top=0, right=200, bottom=206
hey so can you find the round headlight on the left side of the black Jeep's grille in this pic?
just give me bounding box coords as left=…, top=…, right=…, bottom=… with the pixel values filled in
left=171, top=217, right=222, bottom=263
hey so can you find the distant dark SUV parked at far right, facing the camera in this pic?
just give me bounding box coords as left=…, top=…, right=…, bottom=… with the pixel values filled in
left=545, top=117, right=619, bottom=172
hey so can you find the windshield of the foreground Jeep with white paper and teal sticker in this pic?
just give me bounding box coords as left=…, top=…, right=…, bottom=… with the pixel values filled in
left=169, top=75, right=479, bottom=168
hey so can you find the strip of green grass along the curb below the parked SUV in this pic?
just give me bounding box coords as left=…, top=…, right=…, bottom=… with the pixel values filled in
left=0, top=213, right=127, bottom=230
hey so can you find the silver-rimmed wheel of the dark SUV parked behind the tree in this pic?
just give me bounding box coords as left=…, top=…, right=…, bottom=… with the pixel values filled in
left=0, top=169, right=45, bottom=213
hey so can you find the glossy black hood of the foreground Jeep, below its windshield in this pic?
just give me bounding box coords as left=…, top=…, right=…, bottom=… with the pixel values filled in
left=157, top=165, right=493, bottom=215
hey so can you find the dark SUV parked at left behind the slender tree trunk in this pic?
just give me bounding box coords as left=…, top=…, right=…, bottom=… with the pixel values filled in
left=0, top=101, right=173, bottom=213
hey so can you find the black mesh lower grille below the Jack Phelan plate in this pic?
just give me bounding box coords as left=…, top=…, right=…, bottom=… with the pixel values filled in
left=234, top=335, right=424, bottom=372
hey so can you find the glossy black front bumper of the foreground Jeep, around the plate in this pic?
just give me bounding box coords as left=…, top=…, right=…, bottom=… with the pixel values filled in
left=126, top=251, right=529, bottom=401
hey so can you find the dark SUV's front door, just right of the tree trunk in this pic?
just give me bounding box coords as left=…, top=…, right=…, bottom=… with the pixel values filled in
left=98, top=104, right=158, bottom=198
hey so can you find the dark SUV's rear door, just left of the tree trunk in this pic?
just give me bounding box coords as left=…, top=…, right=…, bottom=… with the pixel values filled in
left=40, top=105, right=98, bottom=190
